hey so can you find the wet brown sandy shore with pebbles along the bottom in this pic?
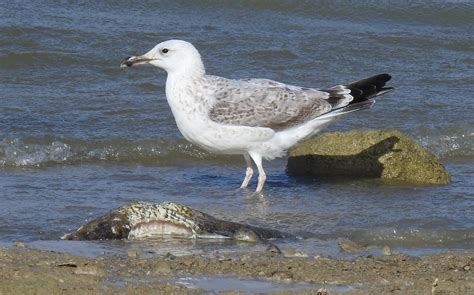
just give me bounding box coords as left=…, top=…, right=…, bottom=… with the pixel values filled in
left=0, top=245, right=474, bottom=294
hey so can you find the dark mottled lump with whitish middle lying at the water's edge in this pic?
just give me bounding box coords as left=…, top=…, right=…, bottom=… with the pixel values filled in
left=61, top=202, right=290, bottom=242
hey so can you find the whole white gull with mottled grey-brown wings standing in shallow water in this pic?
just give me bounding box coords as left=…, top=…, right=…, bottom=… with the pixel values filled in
left=120, top=40, right=393, bottom=193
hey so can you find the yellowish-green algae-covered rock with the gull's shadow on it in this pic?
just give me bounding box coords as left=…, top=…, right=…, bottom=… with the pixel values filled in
left=287, top=130, right=451, bottom=184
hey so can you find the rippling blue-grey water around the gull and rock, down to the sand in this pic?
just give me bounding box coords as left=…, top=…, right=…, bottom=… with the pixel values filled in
left=0, top=1, right=474, bottom=256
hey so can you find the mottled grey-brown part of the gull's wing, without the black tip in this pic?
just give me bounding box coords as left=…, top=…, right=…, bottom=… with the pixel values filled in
left=209, top=80, right=332, bottom=130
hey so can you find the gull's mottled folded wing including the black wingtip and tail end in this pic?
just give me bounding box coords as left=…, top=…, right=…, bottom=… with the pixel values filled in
left=209, top=74, right=392, bottom=130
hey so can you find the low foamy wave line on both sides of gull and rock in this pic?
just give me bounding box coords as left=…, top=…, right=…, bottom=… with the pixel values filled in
left=0, top=127, right=474, bottom=168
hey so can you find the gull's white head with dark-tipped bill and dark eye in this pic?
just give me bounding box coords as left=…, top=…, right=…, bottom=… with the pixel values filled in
left=120, top=40, right=205, bottom=74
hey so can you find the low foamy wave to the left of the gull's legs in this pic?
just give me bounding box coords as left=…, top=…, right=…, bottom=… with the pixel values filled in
left=0, top=136, right=212, bottom=167
